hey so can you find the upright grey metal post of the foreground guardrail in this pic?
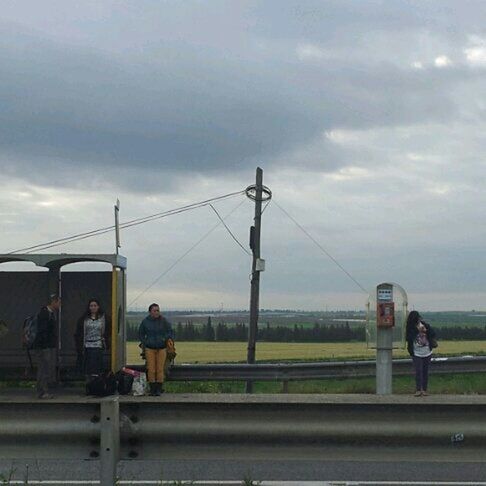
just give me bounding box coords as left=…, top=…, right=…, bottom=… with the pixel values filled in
left=100, top=397, right=120, bottom=486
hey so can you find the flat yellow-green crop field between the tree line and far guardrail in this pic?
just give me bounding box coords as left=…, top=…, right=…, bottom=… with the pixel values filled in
left=127, top=341, right=486, bottom=364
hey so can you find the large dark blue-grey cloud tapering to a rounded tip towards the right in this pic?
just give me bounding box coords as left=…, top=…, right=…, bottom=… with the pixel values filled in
left=0, top=21, right=319, bottom=178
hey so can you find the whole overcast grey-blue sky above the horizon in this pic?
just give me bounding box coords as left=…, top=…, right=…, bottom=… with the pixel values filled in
left=0, top=0, right=486, bottom=309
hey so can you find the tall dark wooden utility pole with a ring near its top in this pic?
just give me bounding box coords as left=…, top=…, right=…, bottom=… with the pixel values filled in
left=246, top=167, right=263, bottom=393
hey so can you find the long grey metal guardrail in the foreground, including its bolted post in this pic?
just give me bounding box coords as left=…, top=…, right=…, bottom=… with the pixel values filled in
left=0, top=395, right=486, bottom=486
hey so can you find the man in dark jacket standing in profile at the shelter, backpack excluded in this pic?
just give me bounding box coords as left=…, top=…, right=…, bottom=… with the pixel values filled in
left=34, top=294, right=61, bottom=399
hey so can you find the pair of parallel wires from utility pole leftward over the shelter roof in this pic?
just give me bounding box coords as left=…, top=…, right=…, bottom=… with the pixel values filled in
left=8, top=191, right=245, bottom=255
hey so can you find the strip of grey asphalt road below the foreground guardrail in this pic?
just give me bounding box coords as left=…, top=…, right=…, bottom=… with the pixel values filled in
left=0, top=460, right=486, bottom=484
